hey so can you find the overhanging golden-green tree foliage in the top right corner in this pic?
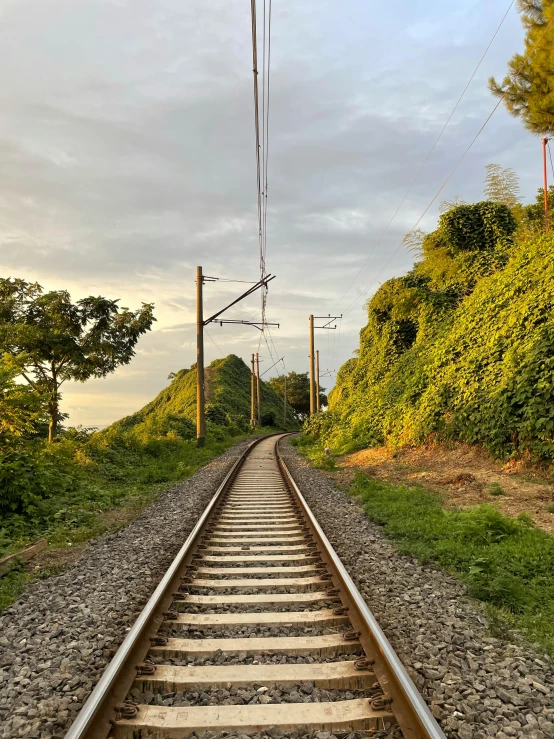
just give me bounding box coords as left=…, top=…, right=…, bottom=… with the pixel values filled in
left=489, top=0, right=554, bottom=134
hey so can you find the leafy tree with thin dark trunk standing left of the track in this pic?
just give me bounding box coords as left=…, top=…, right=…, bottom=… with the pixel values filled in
left=0, top=278, right=155, bottom=441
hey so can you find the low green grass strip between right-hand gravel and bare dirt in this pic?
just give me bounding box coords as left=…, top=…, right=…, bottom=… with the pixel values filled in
left=292, top=435, right=554, bottom=657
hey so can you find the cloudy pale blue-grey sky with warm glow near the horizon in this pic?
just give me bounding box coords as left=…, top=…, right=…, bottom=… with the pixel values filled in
left=0, top=0, right=541, bottom=426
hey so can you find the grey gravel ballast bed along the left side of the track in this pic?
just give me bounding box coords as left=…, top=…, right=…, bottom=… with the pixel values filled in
left=0, top=441, right=249, bottom=739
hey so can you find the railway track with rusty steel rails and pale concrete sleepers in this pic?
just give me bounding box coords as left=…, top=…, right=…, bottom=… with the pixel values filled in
left=66, top=436, right=444, bottom=739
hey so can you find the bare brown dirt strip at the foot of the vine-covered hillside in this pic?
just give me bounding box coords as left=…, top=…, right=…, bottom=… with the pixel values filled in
left=331, top=444, right=554, bottom=533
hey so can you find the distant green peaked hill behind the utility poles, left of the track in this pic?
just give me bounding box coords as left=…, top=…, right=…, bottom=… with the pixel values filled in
left=110, top=354, right=296, bottom=438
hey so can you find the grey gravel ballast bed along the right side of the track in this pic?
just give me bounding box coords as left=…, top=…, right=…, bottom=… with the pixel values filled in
left=280, top=441, right=554, bottom=739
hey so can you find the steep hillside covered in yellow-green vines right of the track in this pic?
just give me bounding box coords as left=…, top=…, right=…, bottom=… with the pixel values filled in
left=311, top=201, right=554, bottom=462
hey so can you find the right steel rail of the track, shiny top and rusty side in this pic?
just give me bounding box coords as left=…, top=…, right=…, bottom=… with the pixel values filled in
left=275, top=440, right=445, bottom=739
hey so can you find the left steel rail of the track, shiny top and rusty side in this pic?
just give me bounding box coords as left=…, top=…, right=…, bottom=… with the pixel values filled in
left=65, top=434, right=273, bottom=739
